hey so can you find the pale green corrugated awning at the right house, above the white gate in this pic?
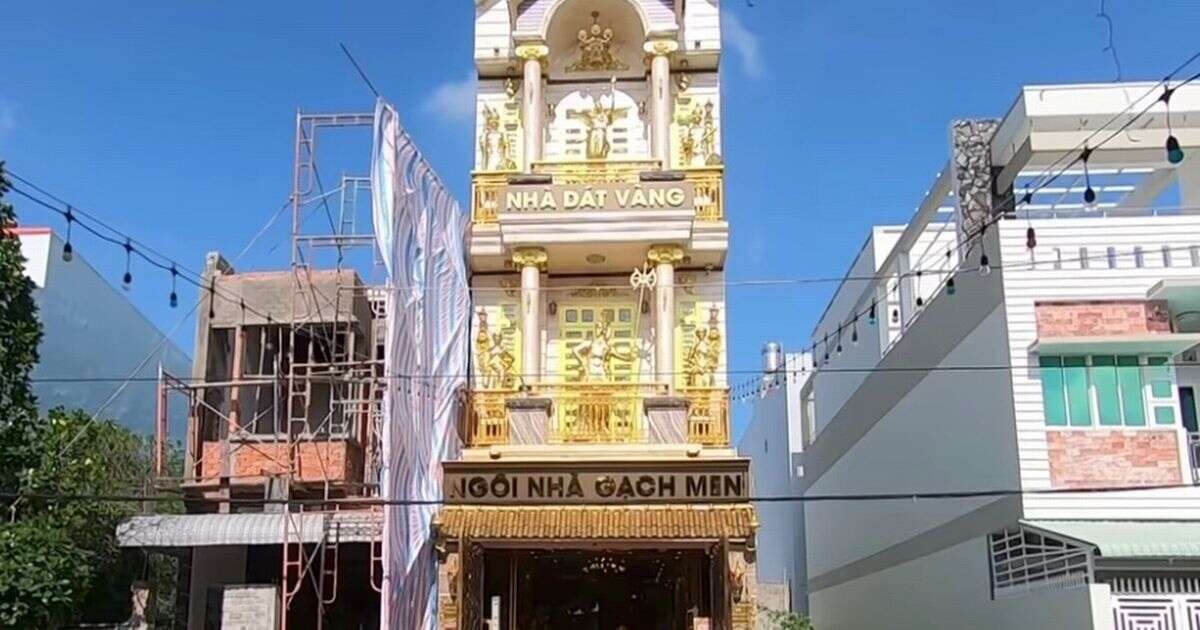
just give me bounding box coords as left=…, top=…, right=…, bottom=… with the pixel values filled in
left=1022, top=521, right=1200, bottom=558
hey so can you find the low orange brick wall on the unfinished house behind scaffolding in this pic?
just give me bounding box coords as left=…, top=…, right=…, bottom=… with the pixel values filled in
left=200, top=440, right=362, bottom=484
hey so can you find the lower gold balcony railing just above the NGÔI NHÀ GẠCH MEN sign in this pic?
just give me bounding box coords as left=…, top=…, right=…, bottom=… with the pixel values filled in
left=462, top=383, right=730, bottom=448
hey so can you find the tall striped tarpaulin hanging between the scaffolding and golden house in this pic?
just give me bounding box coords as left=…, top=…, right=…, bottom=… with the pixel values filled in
left=371, top=100, right=470, bottom=630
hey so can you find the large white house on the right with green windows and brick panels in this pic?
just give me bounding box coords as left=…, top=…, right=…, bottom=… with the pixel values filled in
left=799, top=83, right=1200, bottom=630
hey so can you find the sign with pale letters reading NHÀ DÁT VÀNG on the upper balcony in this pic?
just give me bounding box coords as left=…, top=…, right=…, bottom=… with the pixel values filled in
left=500, top=181, right=696, bottom=212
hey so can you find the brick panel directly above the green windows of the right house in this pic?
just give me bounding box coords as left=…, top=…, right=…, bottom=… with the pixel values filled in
left=1034, top=300, right=1171, bottom=337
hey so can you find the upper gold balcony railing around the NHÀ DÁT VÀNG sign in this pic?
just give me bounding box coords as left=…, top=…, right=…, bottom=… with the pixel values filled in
left=470, top=160, right=725, bottom=223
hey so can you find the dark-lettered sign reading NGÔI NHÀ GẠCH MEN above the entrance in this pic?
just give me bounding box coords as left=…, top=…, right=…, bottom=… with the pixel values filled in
left=443, top=458, right=750, bottom=505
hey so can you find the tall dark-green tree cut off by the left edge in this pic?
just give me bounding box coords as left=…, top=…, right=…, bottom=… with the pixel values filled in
left=0, top=162, right=42, bottom=508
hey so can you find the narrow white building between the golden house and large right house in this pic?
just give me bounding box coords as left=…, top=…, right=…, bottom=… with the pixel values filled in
left=738, top=342, right=812, bottom=612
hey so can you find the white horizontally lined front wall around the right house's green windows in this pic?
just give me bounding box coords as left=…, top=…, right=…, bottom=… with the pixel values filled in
left=998, top=215, right=1200, bottom=518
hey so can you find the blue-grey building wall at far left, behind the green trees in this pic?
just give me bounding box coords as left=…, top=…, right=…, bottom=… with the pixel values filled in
left=14, top=227, right=191, bottom=434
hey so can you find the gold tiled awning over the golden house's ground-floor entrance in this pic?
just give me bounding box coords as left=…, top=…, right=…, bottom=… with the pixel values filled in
left=437, top=504, right=758, bottom=540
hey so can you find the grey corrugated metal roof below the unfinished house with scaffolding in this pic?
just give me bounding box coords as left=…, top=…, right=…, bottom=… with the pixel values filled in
left=116, top=511, right=382, bottom=547
